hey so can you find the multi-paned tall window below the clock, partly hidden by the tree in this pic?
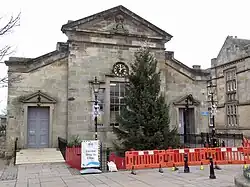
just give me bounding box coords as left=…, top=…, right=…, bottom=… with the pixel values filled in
left=110, top=82, right=125, bottom=126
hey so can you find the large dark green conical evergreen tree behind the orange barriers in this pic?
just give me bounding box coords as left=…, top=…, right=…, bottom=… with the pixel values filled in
left=114, top=48, right=178, bottom=150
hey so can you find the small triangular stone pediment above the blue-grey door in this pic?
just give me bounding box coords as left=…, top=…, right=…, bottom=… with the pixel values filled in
left=22, top=90, right=56, bottom=103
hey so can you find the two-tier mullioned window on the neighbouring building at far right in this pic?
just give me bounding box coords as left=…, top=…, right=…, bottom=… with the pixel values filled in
left=226, top=69, right=238, bottom=126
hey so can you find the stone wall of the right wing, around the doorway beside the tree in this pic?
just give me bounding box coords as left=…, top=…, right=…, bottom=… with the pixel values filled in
left=165, top=60, right=208, bottom=133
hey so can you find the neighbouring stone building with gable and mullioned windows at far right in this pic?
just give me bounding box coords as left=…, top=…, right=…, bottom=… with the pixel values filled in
left=211, top=36, right=250, bottom=136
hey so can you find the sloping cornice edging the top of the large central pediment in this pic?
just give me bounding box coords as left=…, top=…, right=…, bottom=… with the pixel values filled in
left=61, top=5, right=173, bottom=40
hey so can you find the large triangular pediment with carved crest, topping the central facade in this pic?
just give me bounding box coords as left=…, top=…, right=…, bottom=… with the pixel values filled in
left=62, top=5, right=172, bottom=41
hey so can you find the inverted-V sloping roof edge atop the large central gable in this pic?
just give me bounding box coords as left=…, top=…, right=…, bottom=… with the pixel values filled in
left=61, top=5, right=172, bottom=40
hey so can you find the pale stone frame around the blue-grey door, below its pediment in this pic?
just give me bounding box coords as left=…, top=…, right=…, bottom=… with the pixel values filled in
left=20, top=103, right=55, bottom=148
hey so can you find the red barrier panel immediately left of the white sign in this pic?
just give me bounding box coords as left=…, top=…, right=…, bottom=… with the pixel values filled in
left=66, top=147, right=81, bottom=170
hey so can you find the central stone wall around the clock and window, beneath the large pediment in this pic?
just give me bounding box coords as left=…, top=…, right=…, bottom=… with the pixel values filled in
left=68, top=36, right=165, bottom=146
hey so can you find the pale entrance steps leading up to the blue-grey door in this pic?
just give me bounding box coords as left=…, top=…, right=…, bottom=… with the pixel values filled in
left=16, top=148, right=65, bottom=165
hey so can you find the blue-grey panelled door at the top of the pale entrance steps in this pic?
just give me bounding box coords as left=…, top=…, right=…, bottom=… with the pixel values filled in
left=27, top=107, right=49, bottom=148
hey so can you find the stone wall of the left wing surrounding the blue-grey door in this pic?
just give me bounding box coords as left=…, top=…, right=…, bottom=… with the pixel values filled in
left=7, top=58, right=67, bottom=153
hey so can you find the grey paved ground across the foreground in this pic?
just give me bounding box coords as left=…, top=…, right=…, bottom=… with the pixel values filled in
left=0, top=163, right=242, bottom=187
